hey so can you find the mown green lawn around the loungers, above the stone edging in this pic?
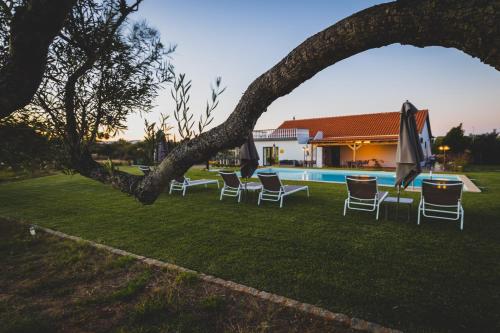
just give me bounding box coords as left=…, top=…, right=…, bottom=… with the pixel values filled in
left=0, top=170, right=500, bottom=332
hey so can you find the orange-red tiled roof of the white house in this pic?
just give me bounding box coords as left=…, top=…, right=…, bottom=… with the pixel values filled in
left=278, top=110, right=429, bottom=141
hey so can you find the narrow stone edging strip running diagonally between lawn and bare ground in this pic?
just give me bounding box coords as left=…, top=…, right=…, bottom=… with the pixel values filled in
left=32, top=225, right=402, bottom=333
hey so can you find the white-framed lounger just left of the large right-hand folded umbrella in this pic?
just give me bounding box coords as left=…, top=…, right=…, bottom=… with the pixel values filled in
left=344, top=176, right=388, bottom=220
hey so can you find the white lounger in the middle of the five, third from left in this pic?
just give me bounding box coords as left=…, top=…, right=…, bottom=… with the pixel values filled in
left=257, top=173, right=309, bottom=208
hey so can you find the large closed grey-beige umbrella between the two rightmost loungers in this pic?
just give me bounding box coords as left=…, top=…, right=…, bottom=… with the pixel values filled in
left=396, top=101, right=424, bottom=188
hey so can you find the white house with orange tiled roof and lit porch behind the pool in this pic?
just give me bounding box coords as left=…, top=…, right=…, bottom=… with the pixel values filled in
left=253, top=110, right=432, bottom=168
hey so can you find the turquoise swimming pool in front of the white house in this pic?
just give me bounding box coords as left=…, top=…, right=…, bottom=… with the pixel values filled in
left=254, top=168, right=461, bottom=187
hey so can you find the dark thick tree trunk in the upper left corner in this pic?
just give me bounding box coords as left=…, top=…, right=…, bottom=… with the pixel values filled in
left=0, top=0, right=76, bottom=119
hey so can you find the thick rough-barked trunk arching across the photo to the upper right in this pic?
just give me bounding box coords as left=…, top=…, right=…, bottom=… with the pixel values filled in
left=86, top=0, right=500, bottom=204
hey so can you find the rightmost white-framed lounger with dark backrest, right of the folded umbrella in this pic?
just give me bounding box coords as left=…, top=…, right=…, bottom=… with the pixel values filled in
left=417, top=179, right=464, bottom=230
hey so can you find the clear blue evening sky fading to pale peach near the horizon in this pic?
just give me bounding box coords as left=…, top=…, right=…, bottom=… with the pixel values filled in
left=121, top=0, right=500, bottom=139
